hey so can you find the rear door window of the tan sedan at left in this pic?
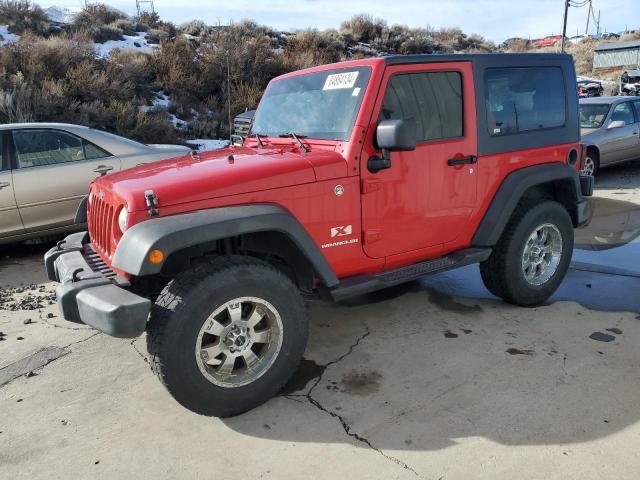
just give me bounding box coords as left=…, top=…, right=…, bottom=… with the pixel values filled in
left=13, top=130, right=84, bottom=168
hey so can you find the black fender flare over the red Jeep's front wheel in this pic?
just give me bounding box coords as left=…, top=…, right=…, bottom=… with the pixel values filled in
left=112, top=204, right=338, bottom=287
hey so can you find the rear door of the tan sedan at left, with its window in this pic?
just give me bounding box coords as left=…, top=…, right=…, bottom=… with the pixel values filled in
left=12, top=129, right=120, bottom=232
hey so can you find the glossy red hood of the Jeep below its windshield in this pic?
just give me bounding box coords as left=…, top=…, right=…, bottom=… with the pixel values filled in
left=95, top=142, right=347, bottom=212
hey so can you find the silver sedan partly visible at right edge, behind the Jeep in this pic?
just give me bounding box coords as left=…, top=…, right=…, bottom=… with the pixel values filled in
left=579, top=97, right=640, bottom=175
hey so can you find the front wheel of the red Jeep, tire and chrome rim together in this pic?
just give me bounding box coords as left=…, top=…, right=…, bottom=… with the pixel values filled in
left=147, top=257, right=308, bottom=417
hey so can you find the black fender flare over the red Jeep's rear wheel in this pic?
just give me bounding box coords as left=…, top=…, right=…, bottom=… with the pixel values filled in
left=471, top=163, right=590, bottom=247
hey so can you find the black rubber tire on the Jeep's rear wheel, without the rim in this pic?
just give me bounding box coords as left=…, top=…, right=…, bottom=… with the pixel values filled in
left=480, top=200, right=573, bottom=307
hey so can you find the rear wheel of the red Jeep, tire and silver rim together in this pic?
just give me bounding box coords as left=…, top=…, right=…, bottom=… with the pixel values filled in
left=480, top=200, right=573, bottom=306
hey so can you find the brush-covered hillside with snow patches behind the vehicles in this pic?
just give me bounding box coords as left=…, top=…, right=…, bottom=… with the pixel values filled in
left=0, top=0, right=636, bottom=143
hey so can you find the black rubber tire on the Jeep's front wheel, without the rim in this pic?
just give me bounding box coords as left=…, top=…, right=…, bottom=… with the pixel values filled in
left=147, top=256, right=308, bottom=417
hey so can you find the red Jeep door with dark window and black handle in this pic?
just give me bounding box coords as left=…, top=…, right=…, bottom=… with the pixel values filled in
left=361, top=62, right=478, bottom=258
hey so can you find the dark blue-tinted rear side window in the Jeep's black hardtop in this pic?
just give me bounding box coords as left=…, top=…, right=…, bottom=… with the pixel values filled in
left=485, top=67, right=565, bottom=135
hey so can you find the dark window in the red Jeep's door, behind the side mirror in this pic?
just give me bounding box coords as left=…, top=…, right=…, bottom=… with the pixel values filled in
left=380, top=72, right=464, bottom=142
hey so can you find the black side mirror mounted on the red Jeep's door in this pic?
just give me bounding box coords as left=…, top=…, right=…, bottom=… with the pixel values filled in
left=367, top=118, right=416, bottom=173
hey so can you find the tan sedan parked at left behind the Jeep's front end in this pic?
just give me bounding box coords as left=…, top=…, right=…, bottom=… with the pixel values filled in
left=0, top=123, right=190, bottom=244
